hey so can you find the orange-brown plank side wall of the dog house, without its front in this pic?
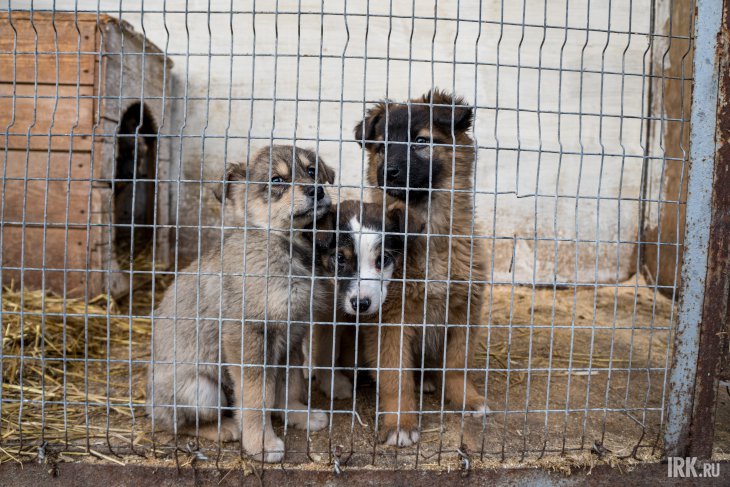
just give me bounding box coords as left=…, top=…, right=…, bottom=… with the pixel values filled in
left=0, top=12, right=102, bottom=296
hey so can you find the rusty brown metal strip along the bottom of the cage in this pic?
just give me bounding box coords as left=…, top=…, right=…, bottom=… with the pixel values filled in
left=0, top=461, right=730, bottom=487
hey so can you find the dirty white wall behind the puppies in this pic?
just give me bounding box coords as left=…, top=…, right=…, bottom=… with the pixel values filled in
left=29, top=0, right=651, bottom=283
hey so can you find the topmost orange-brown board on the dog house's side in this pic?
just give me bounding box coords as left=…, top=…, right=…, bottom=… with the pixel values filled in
left=0, top=12, right=98, bottom=85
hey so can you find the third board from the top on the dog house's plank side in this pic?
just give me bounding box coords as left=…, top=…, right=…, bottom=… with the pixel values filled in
left=0, top=151, right=92, bottom=226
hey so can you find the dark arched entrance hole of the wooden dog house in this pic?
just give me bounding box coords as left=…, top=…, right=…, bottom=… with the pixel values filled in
left=114, top=103, right=157, bottom=263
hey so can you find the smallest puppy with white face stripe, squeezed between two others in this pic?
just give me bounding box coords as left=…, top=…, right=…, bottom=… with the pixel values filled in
left=308, top=201, right=425, bottom=445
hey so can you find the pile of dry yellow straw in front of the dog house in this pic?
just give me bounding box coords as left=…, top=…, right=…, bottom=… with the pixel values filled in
left=0, top=248, right=171, bottom=463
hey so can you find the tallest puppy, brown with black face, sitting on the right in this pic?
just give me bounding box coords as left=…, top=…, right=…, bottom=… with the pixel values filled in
left=355, top=90, right=488, bottom=446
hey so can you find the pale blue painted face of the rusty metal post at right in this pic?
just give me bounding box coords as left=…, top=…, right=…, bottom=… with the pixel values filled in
left=664, top=0, right=728, bottom=462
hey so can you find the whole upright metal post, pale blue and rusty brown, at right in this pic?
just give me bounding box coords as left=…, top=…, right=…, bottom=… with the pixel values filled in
left=664, top=0, right=730, bottom=458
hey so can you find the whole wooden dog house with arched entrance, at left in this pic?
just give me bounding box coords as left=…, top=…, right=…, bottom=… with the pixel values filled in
left=0, top=12, right=171, bottom=298
